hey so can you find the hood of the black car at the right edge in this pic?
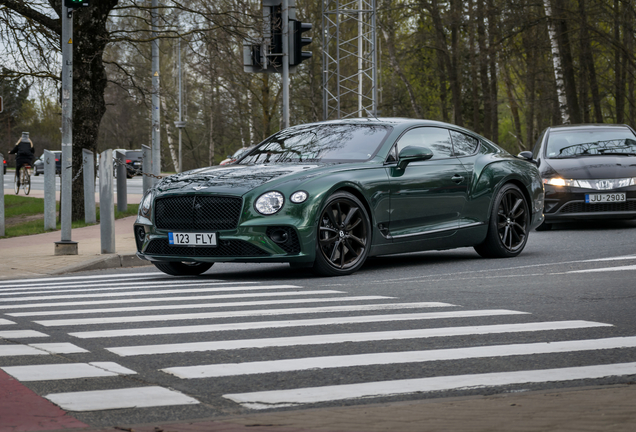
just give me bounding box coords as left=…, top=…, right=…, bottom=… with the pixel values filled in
left=541, top=156, right=636, bottom=179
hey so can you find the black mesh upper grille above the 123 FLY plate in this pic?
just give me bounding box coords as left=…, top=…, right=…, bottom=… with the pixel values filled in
left=155, top=195, right=243, bottom=231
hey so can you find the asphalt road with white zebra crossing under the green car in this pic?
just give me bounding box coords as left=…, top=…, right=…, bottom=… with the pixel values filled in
left=0, top=221, right=636, bottom=426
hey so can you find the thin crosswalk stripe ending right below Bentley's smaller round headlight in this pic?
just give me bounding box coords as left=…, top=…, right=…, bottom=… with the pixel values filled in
left=0, top=284, right=301, bottom=302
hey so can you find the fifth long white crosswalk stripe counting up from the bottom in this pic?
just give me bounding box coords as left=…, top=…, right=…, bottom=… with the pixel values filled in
left=34, top=302, right=452, bottom=327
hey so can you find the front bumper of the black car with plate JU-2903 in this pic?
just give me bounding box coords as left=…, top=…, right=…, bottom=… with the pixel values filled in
left=544, top=185, right=636, bottom=222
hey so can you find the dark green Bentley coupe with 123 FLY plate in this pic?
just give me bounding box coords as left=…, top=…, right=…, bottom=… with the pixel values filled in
left=134, top=118, right=544, bottom=276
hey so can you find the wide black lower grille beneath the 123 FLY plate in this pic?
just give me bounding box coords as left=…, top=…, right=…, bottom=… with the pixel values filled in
left=144, top=239, right=269, bottom=257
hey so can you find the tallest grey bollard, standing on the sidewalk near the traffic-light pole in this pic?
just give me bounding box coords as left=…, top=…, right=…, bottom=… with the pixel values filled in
left=99, top=150, right=115, bottom=254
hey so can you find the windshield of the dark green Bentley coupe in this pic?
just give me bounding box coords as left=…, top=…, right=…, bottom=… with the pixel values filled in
left=238, top=124, right=390, bottom=165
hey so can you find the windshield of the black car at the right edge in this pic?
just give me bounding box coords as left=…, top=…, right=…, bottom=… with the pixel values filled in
left=546, top=128, right=636, bottom=159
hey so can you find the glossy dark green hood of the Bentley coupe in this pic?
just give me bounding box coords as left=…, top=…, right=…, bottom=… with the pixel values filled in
left=157, top=164, right=321, bottom=195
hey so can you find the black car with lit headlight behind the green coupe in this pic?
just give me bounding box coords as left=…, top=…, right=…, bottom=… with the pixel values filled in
left=532, top=124, right=636, bottom=230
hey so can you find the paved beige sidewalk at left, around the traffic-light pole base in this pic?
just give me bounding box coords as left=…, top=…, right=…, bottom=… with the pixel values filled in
left=0, top=216, right=150, bottom=280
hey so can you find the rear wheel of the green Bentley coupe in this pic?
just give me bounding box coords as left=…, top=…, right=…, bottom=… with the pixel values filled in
left=475, top=183, right=530, bottom=258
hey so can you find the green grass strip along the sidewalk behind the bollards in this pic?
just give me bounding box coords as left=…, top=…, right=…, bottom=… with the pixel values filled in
left=0, top=195, right=139, bottom=238
